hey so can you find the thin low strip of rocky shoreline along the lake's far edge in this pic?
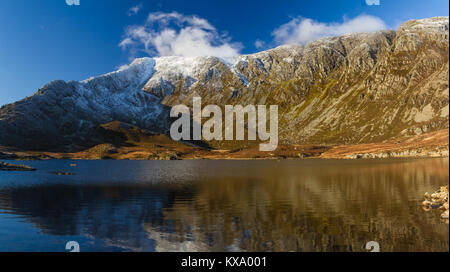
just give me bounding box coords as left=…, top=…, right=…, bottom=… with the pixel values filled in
left=0, top=145, right=449, bottom=161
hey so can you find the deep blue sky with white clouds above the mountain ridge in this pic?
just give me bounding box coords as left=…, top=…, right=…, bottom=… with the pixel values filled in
left=0, top=0, right=449, bottom=105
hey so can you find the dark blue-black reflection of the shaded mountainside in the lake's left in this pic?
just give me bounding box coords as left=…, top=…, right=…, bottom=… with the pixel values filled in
left=0, top=185, right=196, bottom=250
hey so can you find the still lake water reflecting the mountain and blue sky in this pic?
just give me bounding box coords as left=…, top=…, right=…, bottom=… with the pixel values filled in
left=0, top=159, right=449, bottom=252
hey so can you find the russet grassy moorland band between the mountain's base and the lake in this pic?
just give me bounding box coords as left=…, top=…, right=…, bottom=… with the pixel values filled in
left=0, top=129, right=449, bottom=161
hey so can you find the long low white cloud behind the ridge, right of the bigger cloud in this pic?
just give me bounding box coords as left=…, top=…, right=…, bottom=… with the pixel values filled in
left=272, top=14, right=387, bottom=44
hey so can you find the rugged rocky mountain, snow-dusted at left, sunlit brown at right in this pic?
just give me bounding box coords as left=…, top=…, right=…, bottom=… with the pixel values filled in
left=0, top=17, right=449, bottom=149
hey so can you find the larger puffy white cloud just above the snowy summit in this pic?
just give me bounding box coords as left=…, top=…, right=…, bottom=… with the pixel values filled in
left=119, top=12, right=242, bottom=59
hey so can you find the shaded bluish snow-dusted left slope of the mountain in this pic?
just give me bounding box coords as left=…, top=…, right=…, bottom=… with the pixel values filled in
left=0, top=58, right=168, bottom=149
